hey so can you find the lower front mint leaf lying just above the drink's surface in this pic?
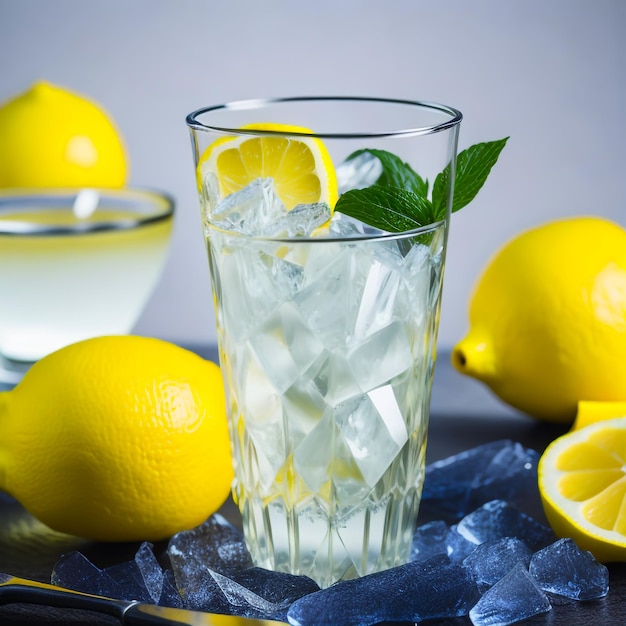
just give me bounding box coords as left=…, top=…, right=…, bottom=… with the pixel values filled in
left=335, top=184, right=437, bottom=233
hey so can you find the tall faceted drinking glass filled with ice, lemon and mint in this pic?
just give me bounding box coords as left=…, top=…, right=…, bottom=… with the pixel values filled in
left=187, top=97, right=461, bottom=586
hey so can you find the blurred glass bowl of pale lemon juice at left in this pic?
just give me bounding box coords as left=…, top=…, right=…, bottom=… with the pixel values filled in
left=0, top=189, right=174, bottom=383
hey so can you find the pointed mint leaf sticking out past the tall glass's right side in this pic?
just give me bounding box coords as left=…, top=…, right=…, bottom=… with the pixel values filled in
left=433, top=137, right=509, bottom=219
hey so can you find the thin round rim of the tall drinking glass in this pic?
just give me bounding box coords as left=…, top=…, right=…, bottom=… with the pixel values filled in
left=185, top=96, right=463, bottom=139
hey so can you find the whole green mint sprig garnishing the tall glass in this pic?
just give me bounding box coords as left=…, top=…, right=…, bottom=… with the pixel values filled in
left=335, top=137, right=509, bottom=232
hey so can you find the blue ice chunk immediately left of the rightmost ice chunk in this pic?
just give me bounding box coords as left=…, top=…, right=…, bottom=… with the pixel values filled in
left=463, top=537, right=532, bottom=591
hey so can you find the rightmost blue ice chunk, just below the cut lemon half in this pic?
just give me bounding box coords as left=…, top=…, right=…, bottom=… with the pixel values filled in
left=530, top=539, right=609, bottom=600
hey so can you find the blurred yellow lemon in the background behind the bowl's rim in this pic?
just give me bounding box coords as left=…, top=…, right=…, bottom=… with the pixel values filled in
left=0, top=82, right=128, bottom=188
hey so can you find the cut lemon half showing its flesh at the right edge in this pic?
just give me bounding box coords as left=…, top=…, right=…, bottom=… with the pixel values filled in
left=538, top=418, right=626, bottom=562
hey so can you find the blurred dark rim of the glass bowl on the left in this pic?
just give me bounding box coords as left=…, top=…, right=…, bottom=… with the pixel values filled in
left=0, top=187, right=176, bottom=237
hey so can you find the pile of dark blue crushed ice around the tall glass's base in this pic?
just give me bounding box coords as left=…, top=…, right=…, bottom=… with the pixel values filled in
left=51, top=440, right=609, bottom=626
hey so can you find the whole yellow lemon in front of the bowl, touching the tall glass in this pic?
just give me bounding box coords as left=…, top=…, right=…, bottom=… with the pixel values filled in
left=0, top=336, right=233, bottom=541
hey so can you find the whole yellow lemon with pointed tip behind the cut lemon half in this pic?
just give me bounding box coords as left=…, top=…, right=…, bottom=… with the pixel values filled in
left=452, top=217, right=626, bottom=423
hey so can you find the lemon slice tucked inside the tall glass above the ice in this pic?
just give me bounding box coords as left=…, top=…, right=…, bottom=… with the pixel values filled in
left=197, top=123, right=338, bottom=211
